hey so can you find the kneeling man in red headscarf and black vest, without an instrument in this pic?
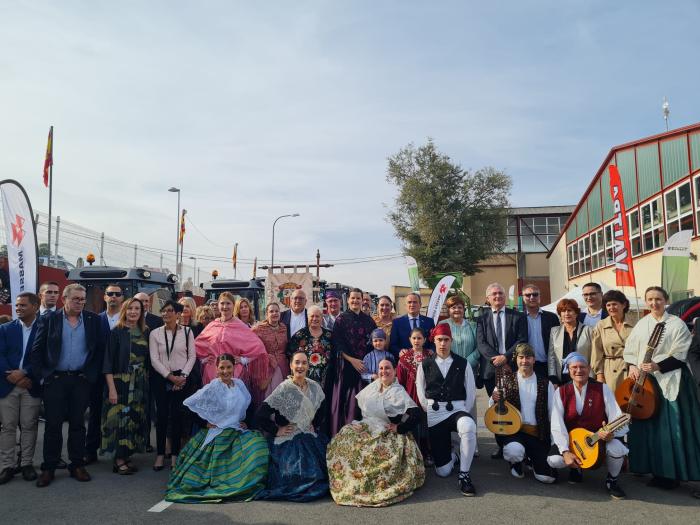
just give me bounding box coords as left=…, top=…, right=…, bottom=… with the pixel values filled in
left=416, top=324, right=476, bottom=496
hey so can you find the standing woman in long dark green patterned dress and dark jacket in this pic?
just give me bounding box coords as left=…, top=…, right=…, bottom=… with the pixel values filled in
left=101, top=299, right=149, bottom=475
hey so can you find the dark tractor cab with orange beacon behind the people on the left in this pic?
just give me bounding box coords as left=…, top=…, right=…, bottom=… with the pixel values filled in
left=67, top=266, right=177, bottom=313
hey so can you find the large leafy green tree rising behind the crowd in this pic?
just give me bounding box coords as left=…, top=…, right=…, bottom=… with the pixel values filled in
left=386, top=139, right=511, bottom=278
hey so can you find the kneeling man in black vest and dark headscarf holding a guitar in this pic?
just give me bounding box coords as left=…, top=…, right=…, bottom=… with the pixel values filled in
left=491, top=343, right=555, bottom=483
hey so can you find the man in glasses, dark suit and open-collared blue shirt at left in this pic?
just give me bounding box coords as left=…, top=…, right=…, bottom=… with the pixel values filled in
left=29, top=284, right=104, bottom=487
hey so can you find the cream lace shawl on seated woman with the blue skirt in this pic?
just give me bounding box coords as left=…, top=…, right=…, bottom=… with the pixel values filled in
left=265, top=379, right=326, bottom=444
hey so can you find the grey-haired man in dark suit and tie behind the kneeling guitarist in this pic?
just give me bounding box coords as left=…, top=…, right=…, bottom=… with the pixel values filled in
left=476, top=283, right=527, bottom=459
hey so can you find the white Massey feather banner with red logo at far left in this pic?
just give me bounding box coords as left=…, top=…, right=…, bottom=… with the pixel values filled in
left=0, top=180, right=39, bottom=318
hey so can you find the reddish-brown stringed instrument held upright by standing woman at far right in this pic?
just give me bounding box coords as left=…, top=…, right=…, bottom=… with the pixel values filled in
left=615, top=323, right=666, bottom=419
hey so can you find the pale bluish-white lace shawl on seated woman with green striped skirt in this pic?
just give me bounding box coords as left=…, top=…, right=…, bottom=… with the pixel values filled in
left=183, top=379, right=250, bottom=447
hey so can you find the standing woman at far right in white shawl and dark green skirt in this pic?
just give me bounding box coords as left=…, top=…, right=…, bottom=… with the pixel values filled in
left=624, top=286, right=700, bottom=489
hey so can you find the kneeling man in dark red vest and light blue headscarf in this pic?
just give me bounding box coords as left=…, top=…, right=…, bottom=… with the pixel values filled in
left=547, top=352, right=628, bottom=499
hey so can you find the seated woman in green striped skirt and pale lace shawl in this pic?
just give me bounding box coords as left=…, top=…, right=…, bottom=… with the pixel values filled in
left=165, top=354, right=269, bottom=503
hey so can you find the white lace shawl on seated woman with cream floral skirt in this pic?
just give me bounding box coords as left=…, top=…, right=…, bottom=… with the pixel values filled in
left=353, top=379, right=416, bottom=434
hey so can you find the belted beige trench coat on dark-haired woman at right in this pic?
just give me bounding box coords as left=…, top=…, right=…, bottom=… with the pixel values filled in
left=591, top=317, right=633, bottom=392
